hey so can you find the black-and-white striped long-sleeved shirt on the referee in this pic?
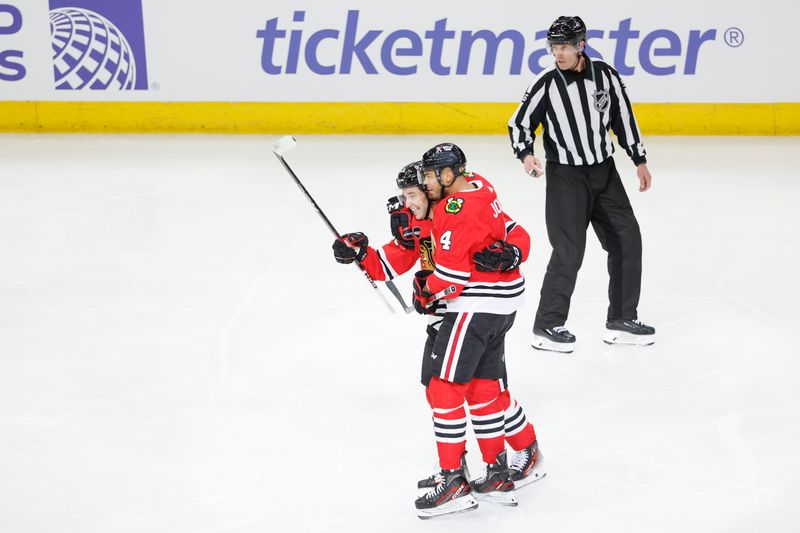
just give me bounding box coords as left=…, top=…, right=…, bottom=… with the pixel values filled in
left=508, top=56, right=647, bottom=165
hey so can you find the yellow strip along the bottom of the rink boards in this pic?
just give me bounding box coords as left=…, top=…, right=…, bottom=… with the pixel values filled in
left=0, top=101, right=800, bottom=135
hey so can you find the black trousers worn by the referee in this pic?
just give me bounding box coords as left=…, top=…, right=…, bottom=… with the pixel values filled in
left=533, top=158, right=642, bottom=329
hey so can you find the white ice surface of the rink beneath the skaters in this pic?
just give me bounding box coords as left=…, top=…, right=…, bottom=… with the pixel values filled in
left=0, top=132, right=800, bottom=533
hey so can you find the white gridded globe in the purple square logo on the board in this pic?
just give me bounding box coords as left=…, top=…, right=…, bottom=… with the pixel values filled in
left=50, top=7, right=136, bottom=90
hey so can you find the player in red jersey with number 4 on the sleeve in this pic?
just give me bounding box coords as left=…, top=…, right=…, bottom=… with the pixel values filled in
left=414, top=143, right=538, bottom=513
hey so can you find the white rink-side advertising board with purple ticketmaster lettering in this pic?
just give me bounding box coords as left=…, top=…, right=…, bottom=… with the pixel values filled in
left=0, top=0, right=800, bottom=103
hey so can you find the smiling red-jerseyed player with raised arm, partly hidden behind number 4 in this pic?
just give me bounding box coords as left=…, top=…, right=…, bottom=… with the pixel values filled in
left=333, top=162, right=545, bottom=516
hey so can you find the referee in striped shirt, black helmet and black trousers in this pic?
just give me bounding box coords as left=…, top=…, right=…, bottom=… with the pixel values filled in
left=508, top=17, right=655, bottom=353
